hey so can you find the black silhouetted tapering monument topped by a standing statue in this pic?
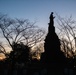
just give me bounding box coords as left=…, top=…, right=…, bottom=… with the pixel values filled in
left=41, top=12, right=66, bottom=66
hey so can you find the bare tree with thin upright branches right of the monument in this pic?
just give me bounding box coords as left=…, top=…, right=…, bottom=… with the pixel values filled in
left=57, top=14, right=76, bottom=57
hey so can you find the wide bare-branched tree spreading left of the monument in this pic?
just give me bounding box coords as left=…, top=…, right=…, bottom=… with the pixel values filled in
left=0, top=14, right=45, bottom=56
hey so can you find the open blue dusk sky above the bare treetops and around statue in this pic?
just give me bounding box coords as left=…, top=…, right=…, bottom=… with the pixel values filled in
left=0, top=0, right=76, bottom=29
